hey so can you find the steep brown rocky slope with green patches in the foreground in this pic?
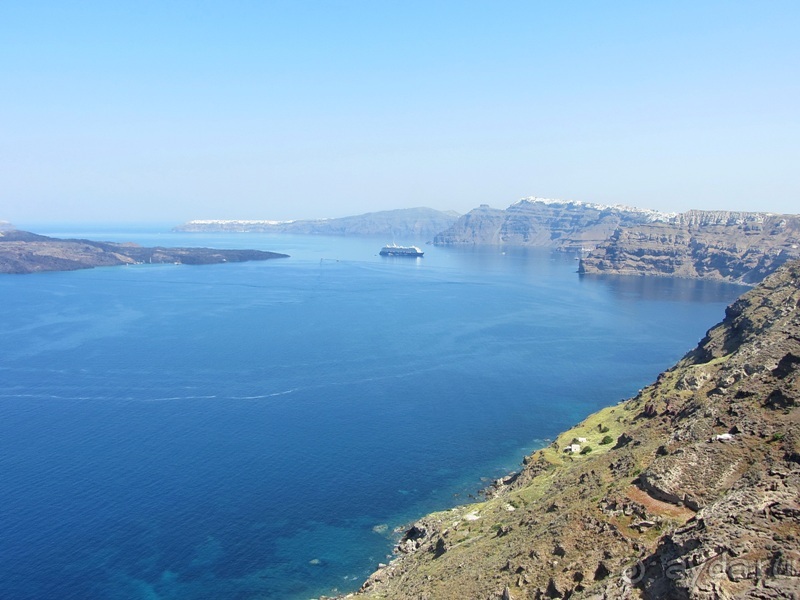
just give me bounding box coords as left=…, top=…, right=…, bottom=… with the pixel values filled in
left=348, top=262, right=800, bottom=600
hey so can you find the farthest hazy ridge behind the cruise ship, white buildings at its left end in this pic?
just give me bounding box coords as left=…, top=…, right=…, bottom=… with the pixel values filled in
left=174, top=208, right=458, bottom=241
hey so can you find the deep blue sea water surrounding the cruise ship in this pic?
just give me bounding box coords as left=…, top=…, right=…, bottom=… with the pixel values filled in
left=0, top=230, right=742, bottom=600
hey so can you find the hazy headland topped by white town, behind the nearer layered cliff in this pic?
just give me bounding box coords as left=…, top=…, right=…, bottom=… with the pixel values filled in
left=433, top=198, right=673, bottom=250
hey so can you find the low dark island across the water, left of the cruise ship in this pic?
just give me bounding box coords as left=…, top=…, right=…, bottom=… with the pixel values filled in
left=0, top=230, right=286, bottom=274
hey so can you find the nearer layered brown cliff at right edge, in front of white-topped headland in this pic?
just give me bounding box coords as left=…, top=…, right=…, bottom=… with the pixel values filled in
left=580, top=210, right=800, bottom=283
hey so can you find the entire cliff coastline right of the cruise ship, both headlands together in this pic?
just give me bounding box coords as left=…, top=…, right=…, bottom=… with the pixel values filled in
left=434, top=198, right=800, bottom=283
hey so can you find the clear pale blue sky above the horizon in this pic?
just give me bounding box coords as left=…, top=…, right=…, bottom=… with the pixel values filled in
left=0, top=0, right=800, bottom=224
